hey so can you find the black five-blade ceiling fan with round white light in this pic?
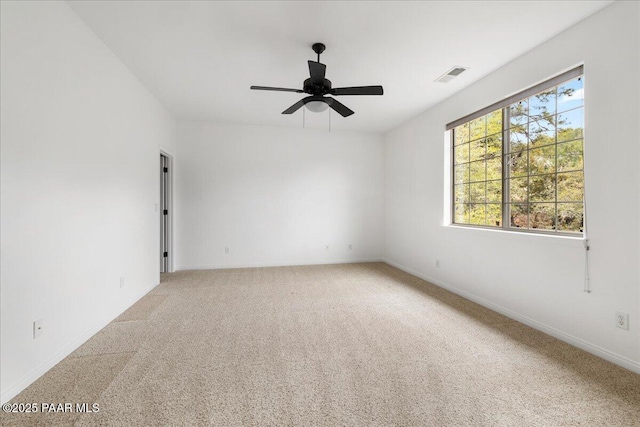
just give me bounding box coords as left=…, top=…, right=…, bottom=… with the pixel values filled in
left=251, top=43, right=383, bottom=117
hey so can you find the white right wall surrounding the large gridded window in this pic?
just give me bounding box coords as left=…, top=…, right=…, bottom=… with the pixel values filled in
left=385, top=2, right=640, bottom=372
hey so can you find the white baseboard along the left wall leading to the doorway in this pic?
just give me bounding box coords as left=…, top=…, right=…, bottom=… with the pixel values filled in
left=0, top=284, right=158, bottom=404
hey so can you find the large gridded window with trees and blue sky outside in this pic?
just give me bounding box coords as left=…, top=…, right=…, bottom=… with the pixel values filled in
left=447, top=67, right=584, bottom=235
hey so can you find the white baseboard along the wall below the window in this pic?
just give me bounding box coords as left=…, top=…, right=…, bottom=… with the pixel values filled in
left=382, top=258, right=640, bottom=374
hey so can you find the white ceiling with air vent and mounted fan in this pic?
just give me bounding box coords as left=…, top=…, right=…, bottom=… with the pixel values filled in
left=67, top=1, right=611, bottom=132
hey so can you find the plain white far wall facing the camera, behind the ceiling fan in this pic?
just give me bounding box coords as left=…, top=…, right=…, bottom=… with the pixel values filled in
left=175, top=122, right=384, bottom=269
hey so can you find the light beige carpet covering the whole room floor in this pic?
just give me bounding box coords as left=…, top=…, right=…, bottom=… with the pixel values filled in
left=0, top=263, right=640, bottom=426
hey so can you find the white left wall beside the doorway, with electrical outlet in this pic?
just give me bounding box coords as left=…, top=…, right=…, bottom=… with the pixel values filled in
left=0, top=1, right=175, bottom=402
